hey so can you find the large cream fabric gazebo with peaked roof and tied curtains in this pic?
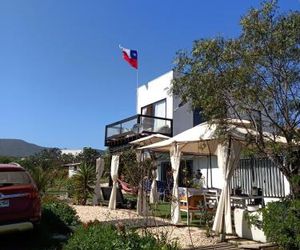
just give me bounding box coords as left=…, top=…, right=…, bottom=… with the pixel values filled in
left=140, top=119, right=285, bottom=233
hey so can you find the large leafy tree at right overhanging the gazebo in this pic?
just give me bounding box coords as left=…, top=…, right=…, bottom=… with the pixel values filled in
left=172, top=1, right=300, bottom=198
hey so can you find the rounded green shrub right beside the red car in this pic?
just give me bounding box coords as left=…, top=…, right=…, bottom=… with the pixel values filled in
left=42, top=199, right=79, bottom=232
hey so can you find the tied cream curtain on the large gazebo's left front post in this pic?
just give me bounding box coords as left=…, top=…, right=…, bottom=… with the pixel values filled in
left=170, top=144, right=181, bottom=225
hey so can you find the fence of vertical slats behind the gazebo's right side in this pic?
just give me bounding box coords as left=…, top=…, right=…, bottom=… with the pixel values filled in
left=231, top=158, right=285, bottom=197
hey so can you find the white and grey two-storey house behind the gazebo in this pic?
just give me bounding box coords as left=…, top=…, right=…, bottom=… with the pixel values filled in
left=105, top=71, right=289, bottom=197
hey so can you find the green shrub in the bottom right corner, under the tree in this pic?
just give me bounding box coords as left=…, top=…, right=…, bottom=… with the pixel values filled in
left=263, top=200, right=300, bottom=250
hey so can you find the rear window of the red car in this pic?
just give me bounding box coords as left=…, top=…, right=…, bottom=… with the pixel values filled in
left=0, top=171, right=31, bottom=186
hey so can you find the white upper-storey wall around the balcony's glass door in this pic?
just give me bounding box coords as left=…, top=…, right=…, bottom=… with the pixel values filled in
left=136, top=71, right=174, bottom=119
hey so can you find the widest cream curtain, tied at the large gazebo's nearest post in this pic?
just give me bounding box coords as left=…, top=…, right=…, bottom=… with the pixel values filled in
left=213, top=139, right=241, bottom=234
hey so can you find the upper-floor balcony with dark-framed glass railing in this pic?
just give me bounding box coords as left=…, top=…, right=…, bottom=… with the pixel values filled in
left=105, top=115, right=173, bottom=147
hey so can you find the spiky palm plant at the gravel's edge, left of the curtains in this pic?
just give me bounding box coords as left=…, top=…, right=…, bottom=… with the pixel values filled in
left=72, top=163, right=96, bottom=205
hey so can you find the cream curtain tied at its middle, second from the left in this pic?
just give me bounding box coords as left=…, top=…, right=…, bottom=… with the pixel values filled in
left=108, top=155, right=120, bottom=210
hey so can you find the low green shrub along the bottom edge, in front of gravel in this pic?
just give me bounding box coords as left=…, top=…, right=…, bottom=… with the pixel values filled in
left=64, top=222, right=177, bottom=250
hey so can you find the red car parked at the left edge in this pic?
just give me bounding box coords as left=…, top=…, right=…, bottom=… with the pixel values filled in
left=0, top=163, right=41, bottom=233
